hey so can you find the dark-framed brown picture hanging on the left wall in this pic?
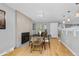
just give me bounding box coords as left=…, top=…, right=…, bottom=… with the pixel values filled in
left=0, top=10, right=6, bottom=29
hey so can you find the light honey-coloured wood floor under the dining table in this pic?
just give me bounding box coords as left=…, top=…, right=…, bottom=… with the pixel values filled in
left=5, top=39, right=73, bottom=56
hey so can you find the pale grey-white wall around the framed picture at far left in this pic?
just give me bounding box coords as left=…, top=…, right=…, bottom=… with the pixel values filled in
left=0, top=4, right=15, bottom=54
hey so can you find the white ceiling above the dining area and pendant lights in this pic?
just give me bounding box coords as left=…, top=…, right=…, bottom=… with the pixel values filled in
left=7, top=3, right=78, bottom=22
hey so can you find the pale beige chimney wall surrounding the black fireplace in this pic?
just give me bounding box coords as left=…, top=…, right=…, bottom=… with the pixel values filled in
left=16, top=11, right=32, bottom=47
